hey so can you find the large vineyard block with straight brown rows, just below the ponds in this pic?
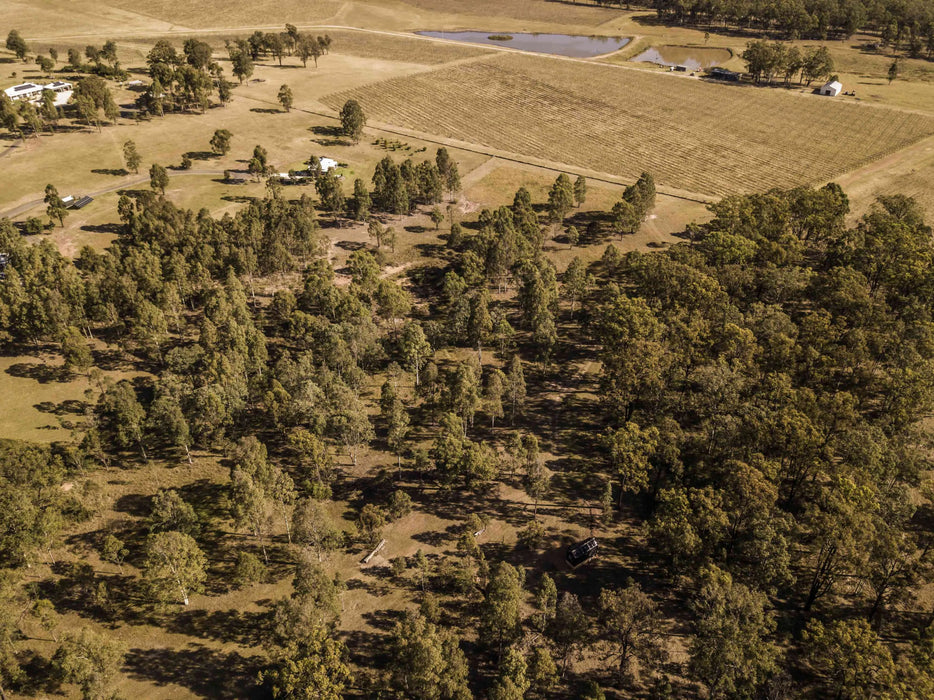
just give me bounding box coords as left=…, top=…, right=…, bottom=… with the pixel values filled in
left=323, top=54, right=934, bottom=195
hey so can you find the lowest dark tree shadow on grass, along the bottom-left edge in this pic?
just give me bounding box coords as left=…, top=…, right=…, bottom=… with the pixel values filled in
left=124, top=644, right=266, bottom=700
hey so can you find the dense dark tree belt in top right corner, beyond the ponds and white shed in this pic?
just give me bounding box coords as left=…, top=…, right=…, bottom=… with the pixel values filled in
left=648, top=0, right=934, bottom=47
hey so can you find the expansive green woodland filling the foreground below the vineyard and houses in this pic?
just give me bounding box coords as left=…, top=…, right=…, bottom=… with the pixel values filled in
left=0, top=141, right=934, bottom=700
